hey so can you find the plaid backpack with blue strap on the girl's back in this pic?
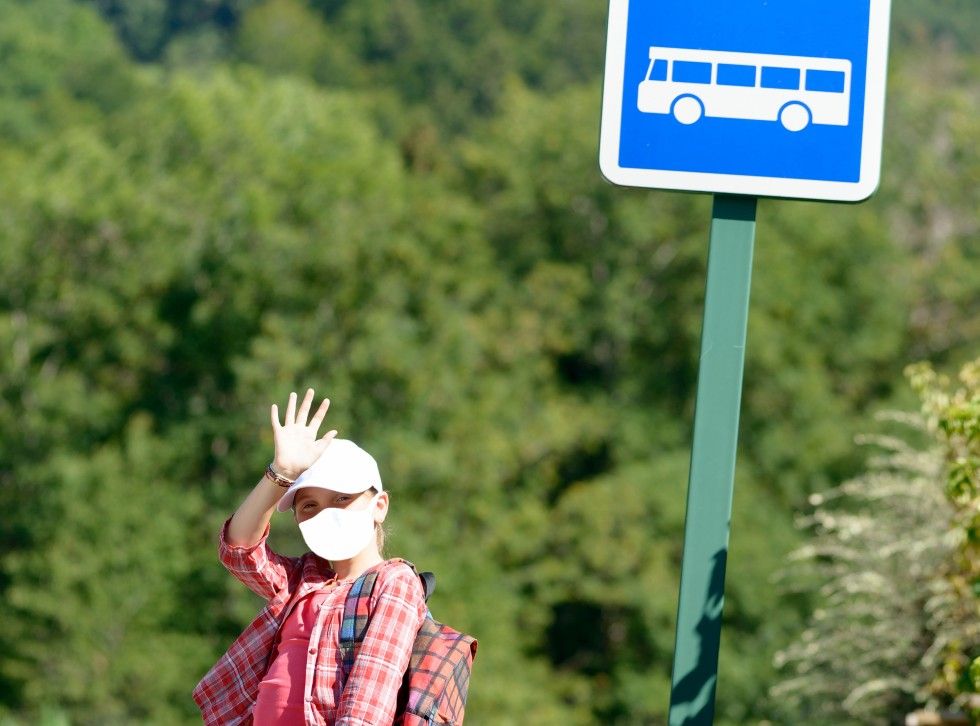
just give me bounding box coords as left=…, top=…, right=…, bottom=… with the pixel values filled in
left=340, top=560, right=476, bottom=726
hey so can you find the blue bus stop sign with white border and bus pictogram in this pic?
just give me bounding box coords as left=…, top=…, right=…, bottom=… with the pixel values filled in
left=599, top=0, right=890, bottom=201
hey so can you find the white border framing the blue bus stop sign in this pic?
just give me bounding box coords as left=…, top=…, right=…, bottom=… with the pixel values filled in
left=599, top=0, right=891, bottom=202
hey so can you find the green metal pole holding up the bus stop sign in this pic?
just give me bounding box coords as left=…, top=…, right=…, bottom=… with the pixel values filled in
left=669, top=195, right=756, bottom=726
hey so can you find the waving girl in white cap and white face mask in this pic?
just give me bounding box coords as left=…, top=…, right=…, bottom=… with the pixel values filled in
left=194, top=389, right=426, bottom=726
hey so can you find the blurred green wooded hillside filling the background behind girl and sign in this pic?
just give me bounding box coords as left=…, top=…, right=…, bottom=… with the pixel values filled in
left=0, top=0, right=980, bottom=725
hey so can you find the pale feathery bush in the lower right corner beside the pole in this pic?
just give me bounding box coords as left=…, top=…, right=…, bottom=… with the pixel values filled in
left=773, top=359, right=980, bottom=724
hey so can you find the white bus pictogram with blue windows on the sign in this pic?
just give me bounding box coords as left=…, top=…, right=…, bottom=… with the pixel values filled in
left=636, top=46, right=851, bottom=131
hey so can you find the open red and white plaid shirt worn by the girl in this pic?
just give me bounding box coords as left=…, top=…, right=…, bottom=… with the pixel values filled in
left=194, top=520, right=426, bottom=726
